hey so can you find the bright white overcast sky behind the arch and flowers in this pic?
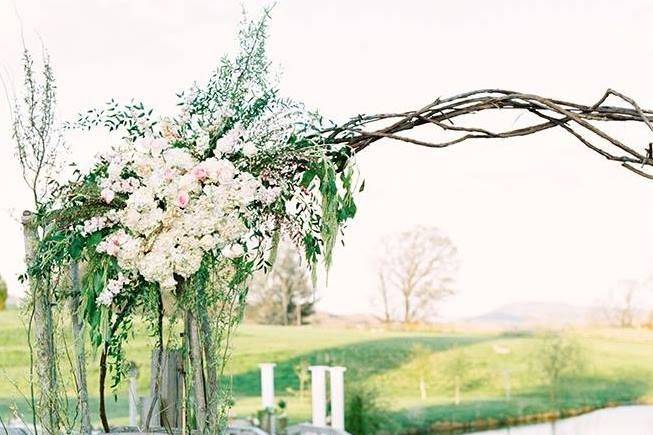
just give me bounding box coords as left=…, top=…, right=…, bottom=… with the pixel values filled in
left=0, top=0, right=653, bottom=317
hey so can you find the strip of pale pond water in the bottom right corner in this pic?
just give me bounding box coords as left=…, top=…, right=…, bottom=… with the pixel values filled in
left=468, top=405, right=653, bottom=435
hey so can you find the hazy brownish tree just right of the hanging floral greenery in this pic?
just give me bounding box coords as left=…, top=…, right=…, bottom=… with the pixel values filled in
left=250, top=243, right=315, bottom=325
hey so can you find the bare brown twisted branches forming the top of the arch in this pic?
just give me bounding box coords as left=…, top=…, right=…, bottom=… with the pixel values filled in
left=322, top=89, right=653, bottom=179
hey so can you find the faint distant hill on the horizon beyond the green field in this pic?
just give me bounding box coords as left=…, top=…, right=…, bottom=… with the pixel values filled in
left=462, top=302, right=601, bottom=328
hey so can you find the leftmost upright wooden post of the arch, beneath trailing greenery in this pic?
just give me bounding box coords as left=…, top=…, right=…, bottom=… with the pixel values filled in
left=21, top=210, right=60, bottom=434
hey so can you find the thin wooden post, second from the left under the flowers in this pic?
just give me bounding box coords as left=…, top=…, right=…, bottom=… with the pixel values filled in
left=70, top=261, right=92, bottom=434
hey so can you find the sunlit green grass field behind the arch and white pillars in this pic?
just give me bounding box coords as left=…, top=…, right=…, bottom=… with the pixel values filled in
left=0, top=310, right=653, bottom=433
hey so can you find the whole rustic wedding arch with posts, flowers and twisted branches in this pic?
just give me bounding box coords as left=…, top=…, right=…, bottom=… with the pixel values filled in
left=14, top=11, right=653, bottom=434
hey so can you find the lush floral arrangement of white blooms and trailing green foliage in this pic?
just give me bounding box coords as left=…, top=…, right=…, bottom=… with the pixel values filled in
left=29, top=13, right=356, bottom=429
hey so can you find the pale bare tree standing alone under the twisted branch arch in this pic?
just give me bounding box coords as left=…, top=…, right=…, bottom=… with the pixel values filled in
left=379, top=226, right=458, bottom=323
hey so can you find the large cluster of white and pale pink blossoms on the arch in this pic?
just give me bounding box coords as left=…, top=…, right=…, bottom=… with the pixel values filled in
left=86, top=126, right=281, bottom=305
